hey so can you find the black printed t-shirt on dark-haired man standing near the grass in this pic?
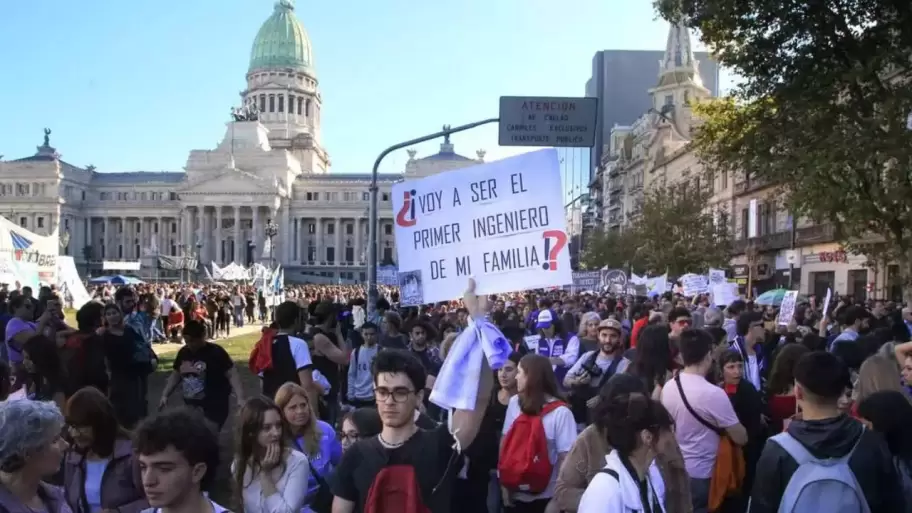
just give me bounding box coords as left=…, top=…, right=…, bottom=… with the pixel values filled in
left=173, top=342, right=234, bottom=416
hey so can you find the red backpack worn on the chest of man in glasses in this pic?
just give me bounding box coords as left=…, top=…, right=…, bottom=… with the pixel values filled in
left=364, top=465, right=431, bottom=513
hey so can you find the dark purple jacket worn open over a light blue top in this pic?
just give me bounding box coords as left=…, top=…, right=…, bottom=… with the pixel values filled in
left=63, top=439, right=149, bottom=513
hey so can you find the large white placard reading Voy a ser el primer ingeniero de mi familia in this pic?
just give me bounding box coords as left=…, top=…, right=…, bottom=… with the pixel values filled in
left=392, top=149, right=572, bottom=304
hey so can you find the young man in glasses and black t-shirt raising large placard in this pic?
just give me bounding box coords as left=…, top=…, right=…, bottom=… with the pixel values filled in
left=330, top=285, right=494, bottom=513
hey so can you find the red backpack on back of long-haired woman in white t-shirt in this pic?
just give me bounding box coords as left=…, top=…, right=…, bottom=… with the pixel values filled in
left=497, top=401, right=567, bottom=494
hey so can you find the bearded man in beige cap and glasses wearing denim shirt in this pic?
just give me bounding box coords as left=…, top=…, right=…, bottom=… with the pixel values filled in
left=564, top=319, right=630, bottom=424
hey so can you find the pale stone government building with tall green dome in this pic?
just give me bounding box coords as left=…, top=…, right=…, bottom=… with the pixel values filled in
left=0, top=0, right=484, bottom=282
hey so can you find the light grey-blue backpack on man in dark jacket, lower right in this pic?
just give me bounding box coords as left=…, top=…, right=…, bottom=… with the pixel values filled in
left=772, top=428, right=871, bottom=513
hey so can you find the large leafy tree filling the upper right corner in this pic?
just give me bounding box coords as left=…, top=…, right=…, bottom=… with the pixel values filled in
left=656, top=0, right=912, bottom=301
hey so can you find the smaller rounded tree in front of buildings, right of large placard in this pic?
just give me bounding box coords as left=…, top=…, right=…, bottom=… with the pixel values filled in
left=630, top=176, right=731, bottom=276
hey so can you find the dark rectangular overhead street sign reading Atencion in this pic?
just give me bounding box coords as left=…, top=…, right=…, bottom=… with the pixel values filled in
left=499, top=96, right=598, bottom=148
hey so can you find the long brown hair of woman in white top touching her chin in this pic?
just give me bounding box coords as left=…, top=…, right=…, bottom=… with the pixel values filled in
left=234, top=396, right=289, bottom=510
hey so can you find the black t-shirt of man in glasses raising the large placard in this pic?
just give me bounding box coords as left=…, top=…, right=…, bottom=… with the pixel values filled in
left=330, top=425, right=460, bottom=513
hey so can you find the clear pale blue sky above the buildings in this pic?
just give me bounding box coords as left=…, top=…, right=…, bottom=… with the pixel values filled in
left=0, top=0, right=728, bottom=194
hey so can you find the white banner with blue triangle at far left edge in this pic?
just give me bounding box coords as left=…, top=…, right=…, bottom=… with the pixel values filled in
left=0, top=212, right=60, bottom=284
